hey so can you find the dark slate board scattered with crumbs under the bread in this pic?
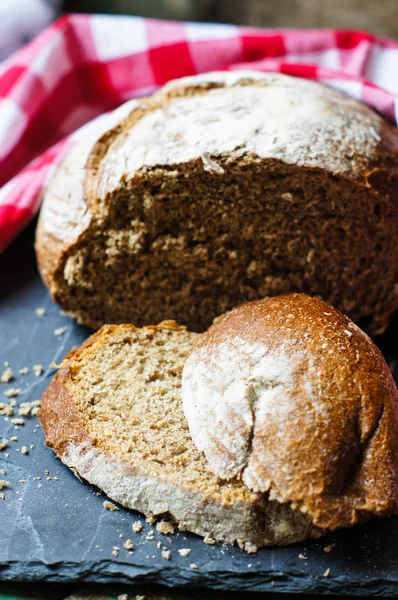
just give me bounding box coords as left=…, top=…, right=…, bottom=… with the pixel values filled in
left=0, top=221, right=398, bottom=595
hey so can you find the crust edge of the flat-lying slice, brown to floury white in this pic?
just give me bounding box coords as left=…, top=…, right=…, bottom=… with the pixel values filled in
left=39, top=321, right=324, bottom=552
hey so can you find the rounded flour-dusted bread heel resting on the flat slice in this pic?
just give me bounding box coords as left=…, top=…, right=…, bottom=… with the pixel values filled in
left=182, top=294, right=398, bottom=529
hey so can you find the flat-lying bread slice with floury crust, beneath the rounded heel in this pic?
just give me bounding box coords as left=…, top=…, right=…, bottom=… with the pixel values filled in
left=39, top=322, right=322, bottom=551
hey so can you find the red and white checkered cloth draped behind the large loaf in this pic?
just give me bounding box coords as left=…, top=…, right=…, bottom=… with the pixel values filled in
left=0, top=15, right=398, bottom=251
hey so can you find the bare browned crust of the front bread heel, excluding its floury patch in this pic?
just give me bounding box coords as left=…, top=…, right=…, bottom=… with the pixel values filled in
left=187, top=294, right=398, bottom=529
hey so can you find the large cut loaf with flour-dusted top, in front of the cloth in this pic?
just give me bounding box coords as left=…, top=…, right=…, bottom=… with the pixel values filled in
left=36, top=71, right=398, bottom=333
